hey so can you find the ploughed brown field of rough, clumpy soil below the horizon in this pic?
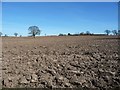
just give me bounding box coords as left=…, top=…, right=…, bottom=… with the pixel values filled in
left=2, top=36, right=120, bottom=88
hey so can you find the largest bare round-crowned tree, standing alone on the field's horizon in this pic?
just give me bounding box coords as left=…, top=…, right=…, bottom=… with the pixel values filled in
left=28, top=26, right=41, bottom=37
